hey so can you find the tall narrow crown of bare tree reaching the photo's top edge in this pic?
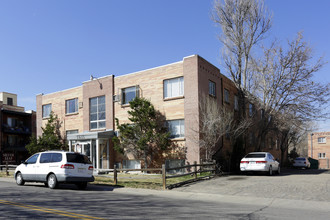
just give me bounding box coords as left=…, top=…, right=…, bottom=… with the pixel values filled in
left=213, top=0, right=272, bottom=91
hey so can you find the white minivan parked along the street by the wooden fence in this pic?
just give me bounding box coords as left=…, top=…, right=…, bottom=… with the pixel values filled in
left=15, top=151, right=94, bottom=189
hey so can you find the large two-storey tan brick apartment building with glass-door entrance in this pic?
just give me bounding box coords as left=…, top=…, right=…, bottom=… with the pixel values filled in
left=37, top=55, right=280, bottom=169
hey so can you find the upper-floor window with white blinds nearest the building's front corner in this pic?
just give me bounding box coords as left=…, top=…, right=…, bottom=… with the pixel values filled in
left=164, top=77, right=184, bottom=99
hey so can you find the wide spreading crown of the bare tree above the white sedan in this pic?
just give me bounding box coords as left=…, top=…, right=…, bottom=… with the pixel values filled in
left=250, top=33, right=330, bottom=156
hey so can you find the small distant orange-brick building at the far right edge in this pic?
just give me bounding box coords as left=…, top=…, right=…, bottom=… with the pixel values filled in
left=308, top=132, right=330, bottom=169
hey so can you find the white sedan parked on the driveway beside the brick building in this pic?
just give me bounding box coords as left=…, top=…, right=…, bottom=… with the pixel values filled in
left=240, top=152, right=281, bottom=175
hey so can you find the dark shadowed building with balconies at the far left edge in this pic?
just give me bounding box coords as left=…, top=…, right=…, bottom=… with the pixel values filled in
left=0, top=92, right=36, bottom=164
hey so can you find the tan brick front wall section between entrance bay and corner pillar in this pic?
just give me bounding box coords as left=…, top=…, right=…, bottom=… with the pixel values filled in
left=114, top=62, right=185, bottom=162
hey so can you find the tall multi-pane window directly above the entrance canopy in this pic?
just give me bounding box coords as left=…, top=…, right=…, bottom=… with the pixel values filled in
left=89, top=96, right=105, bottom=130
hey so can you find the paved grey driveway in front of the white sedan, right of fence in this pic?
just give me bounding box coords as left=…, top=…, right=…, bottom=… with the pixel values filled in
left=173, top=169, right=330, bottom=202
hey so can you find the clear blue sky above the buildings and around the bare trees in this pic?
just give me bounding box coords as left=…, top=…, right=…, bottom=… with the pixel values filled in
left=0, top=0, right=330, bottom=130
